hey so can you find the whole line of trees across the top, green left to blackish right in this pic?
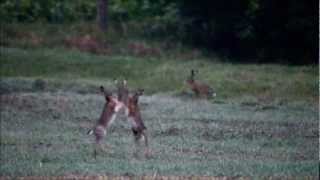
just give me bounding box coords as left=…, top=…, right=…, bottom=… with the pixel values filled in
left=0, top=0, right=319, bottom=64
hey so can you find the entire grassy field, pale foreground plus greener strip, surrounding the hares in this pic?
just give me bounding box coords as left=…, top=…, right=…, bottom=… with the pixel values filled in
left=0, top=23, right=319, bottom=179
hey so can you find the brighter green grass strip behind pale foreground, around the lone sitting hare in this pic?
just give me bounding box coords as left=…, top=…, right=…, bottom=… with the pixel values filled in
left=1, top=47, right=318, bottom=105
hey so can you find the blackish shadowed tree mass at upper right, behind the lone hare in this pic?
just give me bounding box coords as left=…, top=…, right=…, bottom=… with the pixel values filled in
left=179, top=0, right=319, bottom=64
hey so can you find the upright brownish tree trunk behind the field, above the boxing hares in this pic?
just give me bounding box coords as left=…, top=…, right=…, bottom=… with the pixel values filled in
left=97, top=0, right=108, bottom=31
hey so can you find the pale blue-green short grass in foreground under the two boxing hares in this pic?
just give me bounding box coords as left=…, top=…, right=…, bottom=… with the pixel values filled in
left=0, top=88, right=319, bottom=177
